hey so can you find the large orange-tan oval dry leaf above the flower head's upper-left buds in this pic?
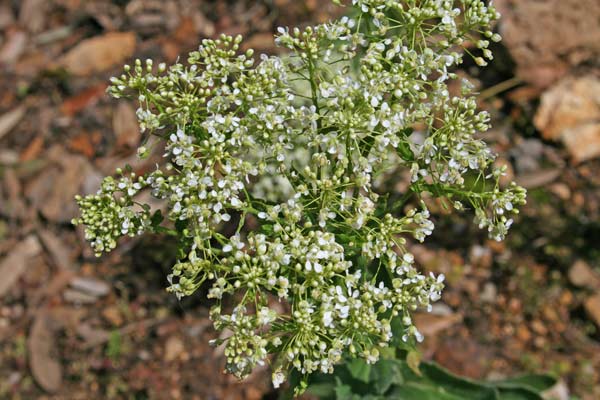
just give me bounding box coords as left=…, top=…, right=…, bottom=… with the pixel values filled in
left=58, top=32, right=135, bottom=76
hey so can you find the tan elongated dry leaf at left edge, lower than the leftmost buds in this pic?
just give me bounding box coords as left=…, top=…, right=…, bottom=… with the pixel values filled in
left=0, top=236, right=42, bottom=297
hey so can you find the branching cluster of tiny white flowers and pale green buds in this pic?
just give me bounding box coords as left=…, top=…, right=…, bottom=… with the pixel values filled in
left=74, top=0, right=525, bottom=394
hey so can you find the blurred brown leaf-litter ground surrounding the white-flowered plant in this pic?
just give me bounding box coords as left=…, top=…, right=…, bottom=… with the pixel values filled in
left=0, top=0, right=600, bottom=400
